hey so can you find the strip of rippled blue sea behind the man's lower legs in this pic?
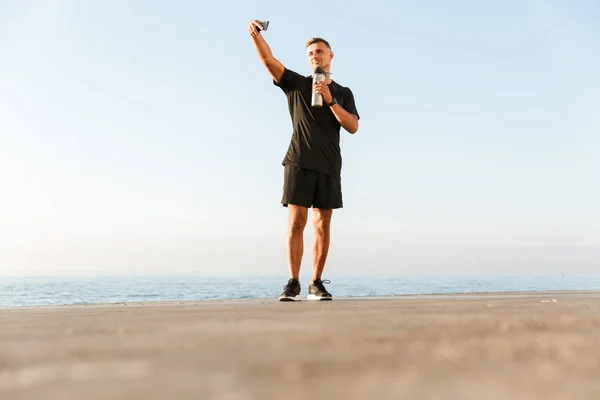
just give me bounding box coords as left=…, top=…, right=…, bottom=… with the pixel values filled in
left=0, top=273, right=600, bottom=308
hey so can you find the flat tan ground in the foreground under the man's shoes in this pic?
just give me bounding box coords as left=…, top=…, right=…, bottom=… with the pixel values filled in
left=0, top=292, right=600, bottom=400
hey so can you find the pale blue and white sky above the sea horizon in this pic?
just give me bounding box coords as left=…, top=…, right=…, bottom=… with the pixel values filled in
left=0, top=0, right=600, bottom=275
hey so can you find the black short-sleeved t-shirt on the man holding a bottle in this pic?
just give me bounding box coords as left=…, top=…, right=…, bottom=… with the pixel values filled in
left=273, top=68, right=359, bottom=178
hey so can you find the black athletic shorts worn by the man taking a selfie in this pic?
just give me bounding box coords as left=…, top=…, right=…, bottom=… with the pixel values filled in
left=281, top=165, right=343, bottom=209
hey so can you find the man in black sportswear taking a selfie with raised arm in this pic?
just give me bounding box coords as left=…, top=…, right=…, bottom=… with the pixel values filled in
left=248, top=21, right=359, bottom=301
